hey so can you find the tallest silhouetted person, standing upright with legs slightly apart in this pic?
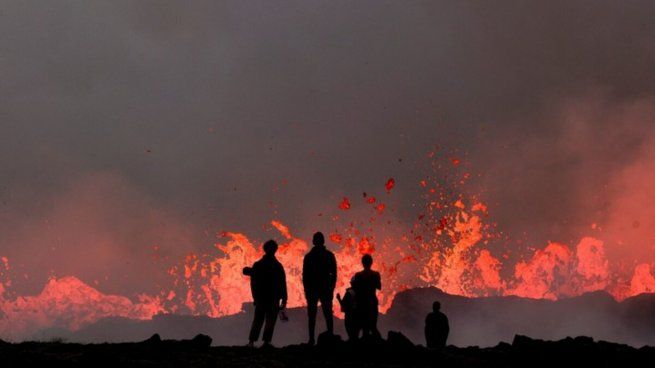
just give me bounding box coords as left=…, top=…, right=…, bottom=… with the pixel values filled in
left=302, top=232, right=337, bottom=345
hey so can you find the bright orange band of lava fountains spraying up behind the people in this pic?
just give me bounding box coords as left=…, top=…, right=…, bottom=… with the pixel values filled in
left=0, top=151, right=655, bottom=339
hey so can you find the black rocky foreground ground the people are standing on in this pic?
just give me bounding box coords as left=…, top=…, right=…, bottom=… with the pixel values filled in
left=0, top=332, right=655, bottom=367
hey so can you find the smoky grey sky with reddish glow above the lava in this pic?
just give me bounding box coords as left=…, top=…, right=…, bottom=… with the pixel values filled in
left=0, top=0, right=655, bottom=292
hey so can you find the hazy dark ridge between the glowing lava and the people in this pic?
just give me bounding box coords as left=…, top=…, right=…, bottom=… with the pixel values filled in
left=32, top=288, right=655, bottom=346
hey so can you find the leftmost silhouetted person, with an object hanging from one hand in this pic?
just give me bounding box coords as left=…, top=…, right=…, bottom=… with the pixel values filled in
left=243, top=240, right=287, bottom=346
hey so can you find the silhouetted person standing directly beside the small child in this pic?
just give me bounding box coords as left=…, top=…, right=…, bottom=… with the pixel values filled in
left=352, top=254, right=382, bottom=338
